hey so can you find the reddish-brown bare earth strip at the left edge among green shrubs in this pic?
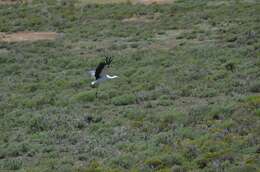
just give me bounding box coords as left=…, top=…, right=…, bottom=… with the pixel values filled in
left=0, top=32, right=58, bottom=42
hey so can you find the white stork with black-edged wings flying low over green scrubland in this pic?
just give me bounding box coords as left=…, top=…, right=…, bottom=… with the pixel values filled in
left=89, top=57, right=118, bottom=97
